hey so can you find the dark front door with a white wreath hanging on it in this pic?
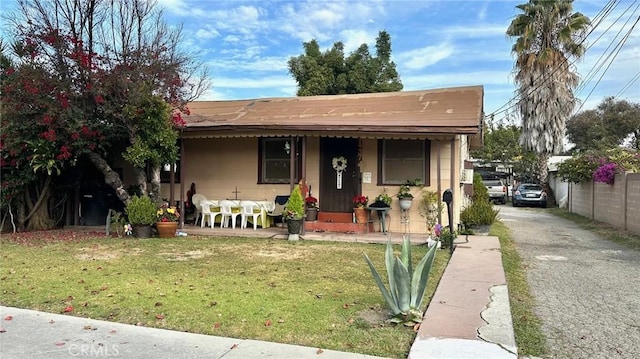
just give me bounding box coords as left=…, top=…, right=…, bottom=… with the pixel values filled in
left=320, top=138, right=360, bottom=212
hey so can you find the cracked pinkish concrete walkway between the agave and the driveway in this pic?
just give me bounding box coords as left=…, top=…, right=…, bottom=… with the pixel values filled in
left=409, top=236, right=517, bottom=359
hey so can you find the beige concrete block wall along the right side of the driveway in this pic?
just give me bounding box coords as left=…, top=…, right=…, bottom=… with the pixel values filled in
left=569, top=173, right=640, bottom=234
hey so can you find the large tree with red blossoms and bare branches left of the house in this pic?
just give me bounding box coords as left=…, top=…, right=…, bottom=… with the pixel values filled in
left=0, top=0, right=207, bottom=229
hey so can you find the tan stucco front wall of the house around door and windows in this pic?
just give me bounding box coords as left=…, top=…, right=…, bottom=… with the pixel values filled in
left=161, top=137, right=462, bottom=234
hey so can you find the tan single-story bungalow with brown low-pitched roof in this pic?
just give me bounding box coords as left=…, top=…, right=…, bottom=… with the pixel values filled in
left=162, top=86, right=483, bottom=233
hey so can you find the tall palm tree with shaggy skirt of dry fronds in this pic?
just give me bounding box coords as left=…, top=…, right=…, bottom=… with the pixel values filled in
left=507, top=0, right=591, bottom=187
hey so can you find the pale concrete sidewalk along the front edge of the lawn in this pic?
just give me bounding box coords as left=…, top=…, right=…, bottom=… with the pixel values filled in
left=0, top=306, right=376, bottom=359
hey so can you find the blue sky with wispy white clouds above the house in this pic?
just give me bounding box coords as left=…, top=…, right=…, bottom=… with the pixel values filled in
left=3, top=0, right=640, bottom=122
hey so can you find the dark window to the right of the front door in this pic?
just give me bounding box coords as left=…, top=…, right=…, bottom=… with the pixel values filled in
left=378, top=140, right=431, bottom=185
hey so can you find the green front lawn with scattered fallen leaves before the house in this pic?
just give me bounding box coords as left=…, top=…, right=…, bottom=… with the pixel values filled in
left=0, top=232, right=449, bottom=358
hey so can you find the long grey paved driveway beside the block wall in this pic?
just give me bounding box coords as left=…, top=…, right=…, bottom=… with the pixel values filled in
left=497, top=206, right=640, bottom=359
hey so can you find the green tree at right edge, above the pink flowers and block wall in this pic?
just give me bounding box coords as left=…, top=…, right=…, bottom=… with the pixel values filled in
left=567, top=97, right=640, bottom=152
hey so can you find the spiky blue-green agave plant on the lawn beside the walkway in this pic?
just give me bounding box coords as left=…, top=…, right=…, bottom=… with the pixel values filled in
left=364, top=236, right=436, bottom=326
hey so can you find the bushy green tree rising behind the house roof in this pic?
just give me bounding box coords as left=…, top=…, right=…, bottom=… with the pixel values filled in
left=288, top=31, right=402, bottom=96
